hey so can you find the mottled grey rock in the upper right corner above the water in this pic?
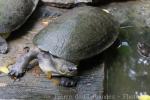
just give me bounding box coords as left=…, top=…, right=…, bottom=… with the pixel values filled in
left=103, top=0, right=150, bottom=27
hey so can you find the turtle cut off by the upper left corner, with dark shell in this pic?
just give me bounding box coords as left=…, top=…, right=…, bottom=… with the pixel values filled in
left=0, top=0, right=39, bottom=54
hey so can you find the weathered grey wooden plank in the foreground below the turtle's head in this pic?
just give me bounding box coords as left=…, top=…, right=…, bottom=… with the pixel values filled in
left=0, top=65, right=104, bottom=100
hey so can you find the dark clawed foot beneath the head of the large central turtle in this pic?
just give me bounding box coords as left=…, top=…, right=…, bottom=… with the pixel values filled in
left=60, top=77, right=78, bottom=87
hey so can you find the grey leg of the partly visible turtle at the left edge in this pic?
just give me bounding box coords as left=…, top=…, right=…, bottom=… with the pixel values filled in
left=0, top=36, right=8, bottom=54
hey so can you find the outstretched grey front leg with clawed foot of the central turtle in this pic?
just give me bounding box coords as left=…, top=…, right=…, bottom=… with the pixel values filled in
left=8, top=50, right=39, bottom=78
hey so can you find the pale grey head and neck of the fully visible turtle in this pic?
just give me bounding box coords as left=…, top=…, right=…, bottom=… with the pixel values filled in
left=37, top=52, right=77, bottom=76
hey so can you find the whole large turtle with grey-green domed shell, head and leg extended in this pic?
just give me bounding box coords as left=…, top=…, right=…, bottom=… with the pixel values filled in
left=9, top=6, right=119, bottom=86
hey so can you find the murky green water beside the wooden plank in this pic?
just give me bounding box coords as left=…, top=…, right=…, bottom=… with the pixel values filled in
left=104, top=26, right=150, bottom=100
